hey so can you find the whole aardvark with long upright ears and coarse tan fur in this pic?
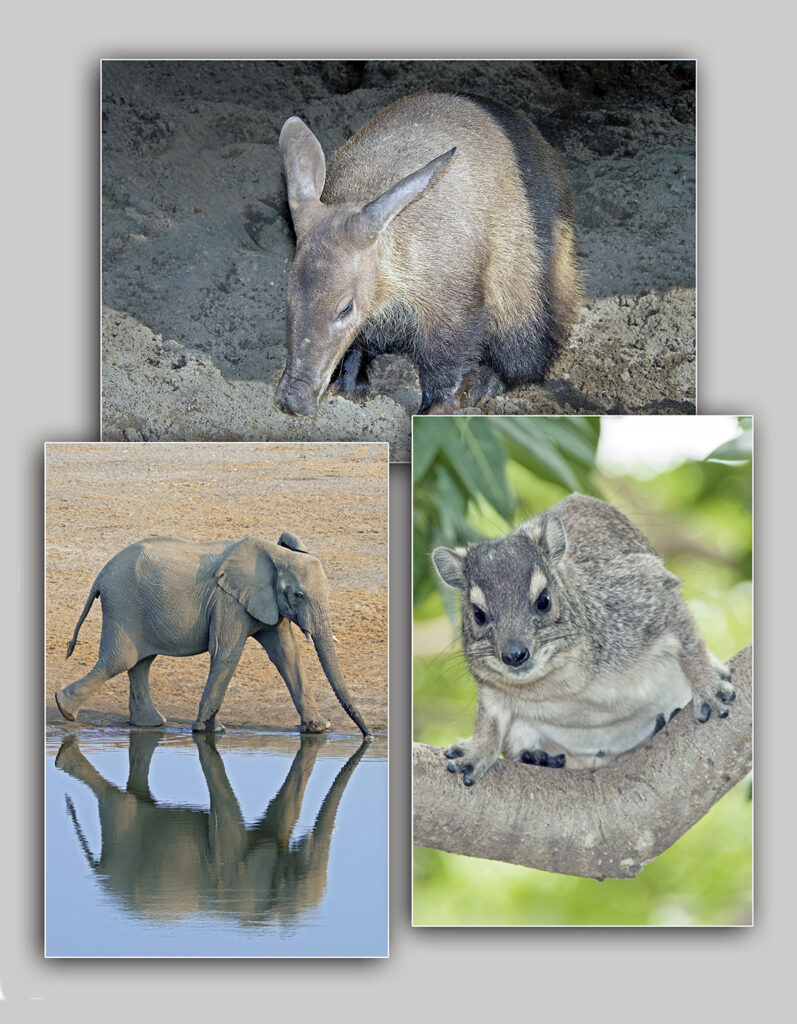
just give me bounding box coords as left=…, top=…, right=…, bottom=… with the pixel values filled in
left=276, top=93, right=581, bottom=415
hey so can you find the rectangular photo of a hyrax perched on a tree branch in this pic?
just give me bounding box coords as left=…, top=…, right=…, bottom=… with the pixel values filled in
left=413, top=416, right=753, bottom=926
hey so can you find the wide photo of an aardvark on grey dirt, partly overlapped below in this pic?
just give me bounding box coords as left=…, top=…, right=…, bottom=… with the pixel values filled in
left=101, top=60, right=696, bottom=462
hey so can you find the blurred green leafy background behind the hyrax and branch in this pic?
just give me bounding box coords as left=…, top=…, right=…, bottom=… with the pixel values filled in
left=413, top=417, right=753, bottom=925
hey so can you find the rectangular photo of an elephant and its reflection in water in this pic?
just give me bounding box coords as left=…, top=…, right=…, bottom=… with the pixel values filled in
left=45, top=443, right=388, bottom=956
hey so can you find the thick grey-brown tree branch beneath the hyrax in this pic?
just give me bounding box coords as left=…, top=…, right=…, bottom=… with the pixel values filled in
left=413, top=647, right=753, bottom=879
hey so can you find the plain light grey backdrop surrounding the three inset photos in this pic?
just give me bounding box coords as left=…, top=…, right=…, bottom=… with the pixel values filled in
left=0, top=0, right=797, bottom=1021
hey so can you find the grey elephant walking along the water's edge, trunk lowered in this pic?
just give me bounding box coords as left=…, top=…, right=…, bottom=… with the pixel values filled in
left=55, top=532, right=371, bottom=739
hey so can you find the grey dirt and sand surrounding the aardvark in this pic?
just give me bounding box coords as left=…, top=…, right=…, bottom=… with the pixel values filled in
left=102, top=61, right=696, bottom=461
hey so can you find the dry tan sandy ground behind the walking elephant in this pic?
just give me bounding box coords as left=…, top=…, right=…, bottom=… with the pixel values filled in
left=45, top=444, right=387, bottom=733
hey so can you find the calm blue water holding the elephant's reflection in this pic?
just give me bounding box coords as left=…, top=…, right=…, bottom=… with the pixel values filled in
left=45, top=730, right=387, bottom=956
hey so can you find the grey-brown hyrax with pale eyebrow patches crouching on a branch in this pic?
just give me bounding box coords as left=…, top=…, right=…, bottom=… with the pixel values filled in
left=432, top=495, right=735, bottom=785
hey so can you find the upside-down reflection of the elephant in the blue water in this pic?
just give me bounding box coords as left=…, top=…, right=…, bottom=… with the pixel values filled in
left=55, top=731, right=368, bottom=925
